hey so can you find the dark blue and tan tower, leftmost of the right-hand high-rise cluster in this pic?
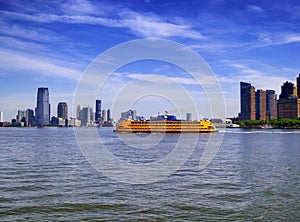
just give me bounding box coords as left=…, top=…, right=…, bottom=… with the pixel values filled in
left=239, top=82, right=256, bottom=120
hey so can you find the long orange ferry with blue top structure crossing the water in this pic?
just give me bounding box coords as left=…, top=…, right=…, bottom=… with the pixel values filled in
left=115, top=114, right=217, bottom=133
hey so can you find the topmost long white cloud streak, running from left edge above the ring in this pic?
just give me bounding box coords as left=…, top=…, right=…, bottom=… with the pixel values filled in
left=0, top=6, right=204, bottom=39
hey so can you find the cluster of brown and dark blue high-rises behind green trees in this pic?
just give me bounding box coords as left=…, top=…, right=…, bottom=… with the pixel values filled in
left=238, top=74, right=300, bottom=121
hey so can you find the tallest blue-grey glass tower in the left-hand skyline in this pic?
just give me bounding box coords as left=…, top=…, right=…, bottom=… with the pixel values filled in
left=35, top=88, right=50, bottom=126
